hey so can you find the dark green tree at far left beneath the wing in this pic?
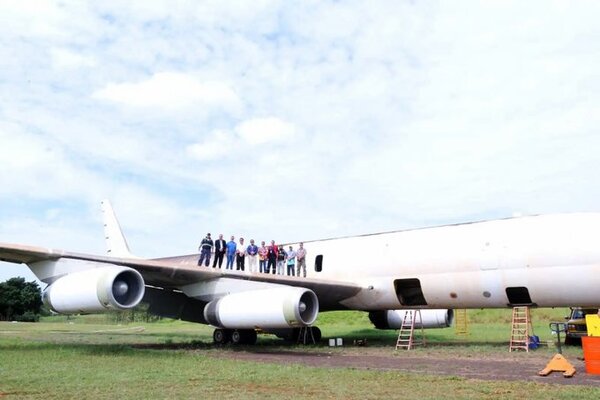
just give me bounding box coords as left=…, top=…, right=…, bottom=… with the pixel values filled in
left=0, top=277, right=42, bottom=321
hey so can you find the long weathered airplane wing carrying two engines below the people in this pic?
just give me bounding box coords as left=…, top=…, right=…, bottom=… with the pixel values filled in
left=0, top=243, right=361, bottom=311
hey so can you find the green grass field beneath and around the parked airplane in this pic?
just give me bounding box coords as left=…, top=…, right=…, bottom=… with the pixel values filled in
left=0, top=310, right=600, bottom=399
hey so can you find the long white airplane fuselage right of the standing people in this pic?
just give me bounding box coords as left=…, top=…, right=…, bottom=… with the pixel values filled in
left=286, top=213, right=600, bottom=310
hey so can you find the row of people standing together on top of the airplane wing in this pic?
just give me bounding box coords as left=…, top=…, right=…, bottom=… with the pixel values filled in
left=198, top=233, right=306, bottom=278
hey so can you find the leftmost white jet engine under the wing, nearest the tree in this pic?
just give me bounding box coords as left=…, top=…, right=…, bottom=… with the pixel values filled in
left=43, top=265, right=145, bottom=314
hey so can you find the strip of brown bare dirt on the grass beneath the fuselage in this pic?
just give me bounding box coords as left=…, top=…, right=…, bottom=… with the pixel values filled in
left=211, top=349, right=600, bottom=387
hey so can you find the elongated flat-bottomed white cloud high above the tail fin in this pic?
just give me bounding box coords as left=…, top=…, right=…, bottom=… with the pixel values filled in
left=92, top=72, right=238, bottom=109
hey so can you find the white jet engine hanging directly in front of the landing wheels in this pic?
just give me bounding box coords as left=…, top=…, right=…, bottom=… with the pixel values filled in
left=204, top=287, right=319, bottom=329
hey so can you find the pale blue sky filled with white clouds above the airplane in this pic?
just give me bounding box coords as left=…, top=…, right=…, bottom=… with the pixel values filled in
left=0, top=0, right=600, bottom=281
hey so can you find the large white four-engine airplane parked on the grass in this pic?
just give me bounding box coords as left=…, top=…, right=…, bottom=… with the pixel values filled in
left=0, top=200, right=600, bottom=344
